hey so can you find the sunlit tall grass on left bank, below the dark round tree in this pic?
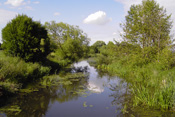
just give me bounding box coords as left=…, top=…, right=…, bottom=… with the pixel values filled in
left=0, top=51, right=50, bottom=95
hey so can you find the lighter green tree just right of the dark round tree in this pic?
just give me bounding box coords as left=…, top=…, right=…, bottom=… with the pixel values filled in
left=45, top=21, right=90, bottom=61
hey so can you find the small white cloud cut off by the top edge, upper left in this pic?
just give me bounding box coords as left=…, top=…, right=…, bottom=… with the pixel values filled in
left=5, top=0, right=26, bottom=7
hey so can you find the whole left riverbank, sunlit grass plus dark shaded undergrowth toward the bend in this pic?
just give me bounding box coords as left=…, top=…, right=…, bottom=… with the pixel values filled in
left=0, top=50, right=70, bottom=98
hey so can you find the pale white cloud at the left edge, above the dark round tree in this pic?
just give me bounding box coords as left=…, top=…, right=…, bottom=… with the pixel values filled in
left=0, top=9, right=17, bottom=25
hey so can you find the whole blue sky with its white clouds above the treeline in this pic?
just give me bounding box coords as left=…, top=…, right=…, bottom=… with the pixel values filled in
left=0, top=0, right=175, bottom=44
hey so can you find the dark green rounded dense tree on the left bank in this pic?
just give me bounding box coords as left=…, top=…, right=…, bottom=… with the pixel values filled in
left=2, top=15, right=50, bottom=61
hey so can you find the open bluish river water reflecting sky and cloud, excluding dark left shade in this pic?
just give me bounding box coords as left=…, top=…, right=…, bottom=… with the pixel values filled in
left=45, top=61, right=128, bottom=117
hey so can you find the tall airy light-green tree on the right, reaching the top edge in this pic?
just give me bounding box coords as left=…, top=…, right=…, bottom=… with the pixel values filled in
left=121, top=0, right=172, bottom=53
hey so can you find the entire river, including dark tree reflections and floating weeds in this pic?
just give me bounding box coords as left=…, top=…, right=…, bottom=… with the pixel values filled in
left=0, top=61, right=172, bottom=117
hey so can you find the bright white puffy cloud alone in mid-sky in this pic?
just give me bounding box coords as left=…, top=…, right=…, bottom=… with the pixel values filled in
left=83, top=11, right=112, bottom=25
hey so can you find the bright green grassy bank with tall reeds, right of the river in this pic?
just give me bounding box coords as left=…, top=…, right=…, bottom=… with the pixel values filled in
left=98, top=54, right=175, bottom=110
